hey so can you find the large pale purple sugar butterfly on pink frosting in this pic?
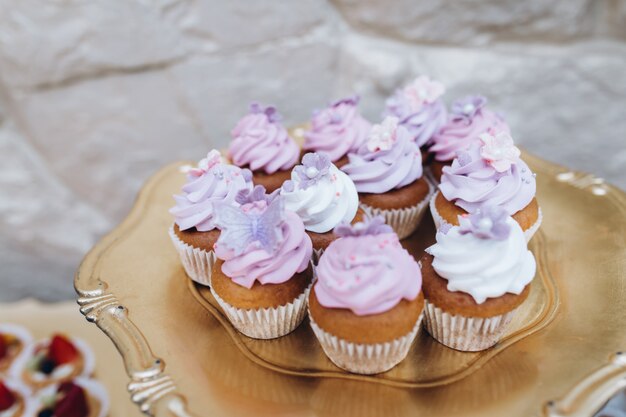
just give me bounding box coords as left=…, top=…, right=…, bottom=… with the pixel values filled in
left=217, top=197, right=284, bottom=256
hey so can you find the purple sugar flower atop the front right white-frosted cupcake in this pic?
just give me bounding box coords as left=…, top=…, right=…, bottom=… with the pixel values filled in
left=459, top=206, right=511, bottom=240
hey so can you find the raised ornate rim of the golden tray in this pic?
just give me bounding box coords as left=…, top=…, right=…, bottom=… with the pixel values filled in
left=74, top=153, right=626, bottom=417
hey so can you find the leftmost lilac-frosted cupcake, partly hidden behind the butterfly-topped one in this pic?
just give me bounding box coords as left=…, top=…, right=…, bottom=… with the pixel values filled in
left=169, top=149, right=252, bottom=285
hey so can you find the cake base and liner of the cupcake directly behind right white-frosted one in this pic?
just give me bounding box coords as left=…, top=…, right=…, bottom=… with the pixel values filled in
left=429, top=191, right=543, bottom=242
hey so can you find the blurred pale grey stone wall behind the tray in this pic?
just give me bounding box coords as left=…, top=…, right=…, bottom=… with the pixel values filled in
left=0, top=0, right=626, bottom=301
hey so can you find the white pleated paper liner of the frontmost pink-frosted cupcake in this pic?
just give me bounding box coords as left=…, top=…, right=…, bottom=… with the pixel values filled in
left=309, top=314, right=423, bottom=375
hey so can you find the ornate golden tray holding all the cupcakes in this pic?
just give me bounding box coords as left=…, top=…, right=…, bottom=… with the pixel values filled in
left=75, top=150, right=626, bottom=417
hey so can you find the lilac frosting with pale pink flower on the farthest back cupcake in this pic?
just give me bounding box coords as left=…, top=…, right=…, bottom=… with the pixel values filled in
left=383, top=76, right=447, bottom=147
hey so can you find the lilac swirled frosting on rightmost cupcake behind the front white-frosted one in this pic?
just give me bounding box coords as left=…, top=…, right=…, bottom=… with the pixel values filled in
left=439, top=136, right=537, bottom=215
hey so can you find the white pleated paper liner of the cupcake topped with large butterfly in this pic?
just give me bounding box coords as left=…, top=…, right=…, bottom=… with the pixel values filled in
left=211, top=285, right=311, bottom=339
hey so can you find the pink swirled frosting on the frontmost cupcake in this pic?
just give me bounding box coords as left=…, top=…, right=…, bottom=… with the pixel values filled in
left=314, top=218, right=422, bottom=316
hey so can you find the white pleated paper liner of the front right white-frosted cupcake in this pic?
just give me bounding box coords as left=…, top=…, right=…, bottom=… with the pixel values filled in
left=424, top=300, right=517, bottom=352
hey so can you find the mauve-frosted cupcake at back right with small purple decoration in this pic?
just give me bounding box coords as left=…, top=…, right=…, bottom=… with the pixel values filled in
left=428, top=96, right=511, bottom=182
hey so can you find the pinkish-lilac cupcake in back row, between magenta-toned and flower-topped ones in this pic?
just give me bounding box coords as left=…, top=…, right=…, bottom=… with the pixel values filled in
left=303, top=97, right=372, bottom=167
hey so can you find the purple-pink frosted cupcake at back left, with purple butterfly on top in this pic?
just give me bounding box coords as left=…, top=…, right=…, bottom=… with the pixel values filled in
left=228, top=103, right=300, bottom=192
